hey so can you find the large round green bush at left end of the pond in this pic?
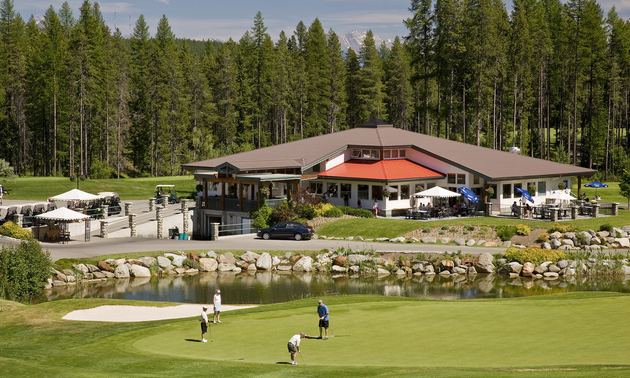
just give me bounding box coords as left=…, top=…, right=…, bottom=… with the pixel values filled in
left=0, top=240, right=52, bottom=301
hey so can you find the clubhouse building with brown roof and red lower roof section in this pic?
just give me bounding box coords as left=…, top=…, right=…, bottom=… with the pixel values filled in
left=184, top=119, right=597, bottom=239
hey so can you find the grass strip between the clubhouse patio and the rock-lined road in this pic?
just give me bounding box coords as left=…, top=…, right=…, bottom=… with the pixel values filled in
left=317, top=210, right=630, bottom=239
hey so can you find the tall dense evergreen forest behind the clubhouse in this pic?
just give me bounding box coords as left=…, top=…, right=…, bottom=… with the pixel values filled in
left=0, top=0, right=630, bottom=179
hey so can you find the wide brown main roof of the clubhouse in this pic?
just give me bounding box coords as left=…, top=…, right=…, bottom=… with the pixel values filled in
left=184, top=120, right=597, bottom=181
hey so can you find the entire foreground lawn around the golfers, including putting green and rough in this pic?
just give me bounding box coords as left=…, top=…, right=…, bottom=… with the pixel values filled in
left=0, top=292, right=630, bottom=377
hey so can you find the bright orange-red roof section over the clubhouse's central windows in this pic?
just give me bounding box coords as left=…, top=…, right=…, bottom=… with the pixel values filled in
left=317, top=159, right=446, bottom=181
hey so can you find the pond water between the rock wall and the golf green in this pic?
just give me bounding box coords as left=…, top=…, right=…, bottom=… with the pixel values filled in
left=36, top=272, right=630, bottom=304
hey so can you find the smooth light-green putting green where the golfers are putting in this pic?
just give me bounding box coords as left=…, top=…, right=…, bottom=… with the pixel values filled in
left=134, top=293, right=630, bottom=369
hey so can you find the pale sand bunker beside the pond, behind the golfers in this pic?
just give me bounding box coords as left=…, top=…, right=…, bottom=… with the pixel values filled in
left=63, top=304, right=256, bottom=322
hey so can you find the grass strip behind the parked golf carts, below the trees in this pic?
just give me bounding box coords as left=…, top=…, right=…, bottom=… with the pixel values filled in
left=3, top=175, right=197, bottom=201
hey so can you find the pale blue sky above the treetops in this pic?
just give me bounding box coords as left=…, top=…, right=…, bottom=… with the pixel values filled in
left=14, top=0, right=630, bottom=41
